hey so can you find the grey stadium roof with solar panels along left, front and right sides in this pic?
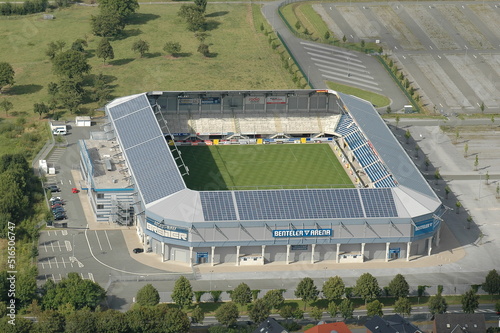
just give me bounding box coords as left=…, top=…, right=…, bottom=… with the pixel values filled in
left=106, top=90, right=441, bottom=222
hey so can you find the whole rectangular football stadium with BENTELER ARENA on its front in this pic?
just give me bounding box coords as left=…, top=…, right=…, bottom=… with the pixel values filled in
left=80, top=90, right=445, bottom=266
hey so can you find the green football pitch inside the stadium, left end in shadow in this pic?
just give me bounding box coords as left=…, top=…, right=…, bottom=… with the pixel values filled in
left=178, top=144, right=354, bottom=191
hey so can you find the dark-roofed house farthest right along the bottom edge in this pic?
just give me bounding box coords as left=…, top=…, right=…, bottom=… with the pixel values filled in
left=432, top=313, right=486, bottom=333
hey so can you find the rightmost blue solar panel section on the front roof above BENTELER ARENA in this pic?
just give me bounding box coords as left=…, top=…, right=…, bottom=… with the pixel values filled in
left=360, top=188, right=398, bottom=217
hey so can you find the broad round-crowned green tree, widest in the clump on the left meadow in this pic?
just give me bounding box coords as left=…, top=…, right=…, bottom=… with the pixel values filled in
left=52, top=50, right=91, bottom=79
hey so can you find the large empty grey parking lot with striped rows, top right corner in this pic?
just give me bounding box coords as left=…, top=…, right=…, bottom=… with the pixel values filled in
left=317, top=1, right=500, bottom=113
